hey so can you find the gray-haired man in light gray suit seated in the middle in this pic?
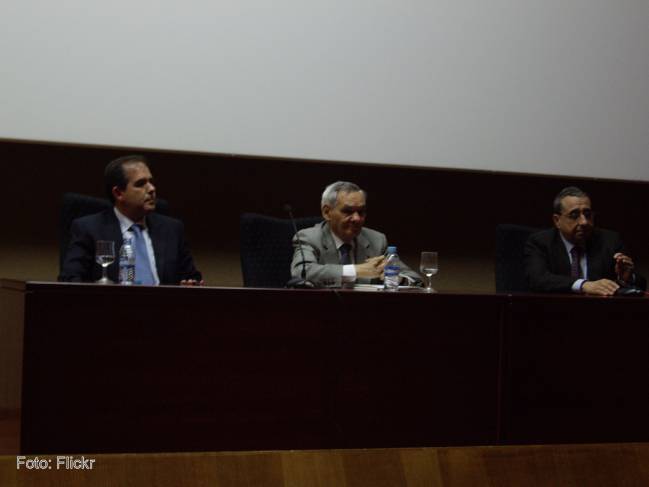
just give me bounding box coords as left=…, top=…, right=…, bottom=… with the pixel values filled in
left=291, top=181, right=422, bottom=287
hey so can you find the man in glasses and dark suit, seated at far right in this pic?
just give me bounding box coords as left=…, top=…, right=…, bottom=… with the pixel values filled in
left=525, top=186, right=647, bottom=296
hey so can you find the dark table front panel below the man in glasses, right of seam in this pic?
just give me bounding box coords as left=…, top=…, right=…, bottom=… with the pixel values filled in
left=503, top=296, right=649, bottom=444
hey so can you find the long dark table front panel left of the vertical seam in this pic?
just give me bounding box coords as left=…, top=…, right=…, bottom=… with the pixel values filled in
left=12, top=284, right=505, bottom=453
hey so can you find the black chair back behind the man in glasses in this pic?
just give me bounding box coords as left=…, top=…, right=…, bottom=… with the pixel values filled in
left=496, top=224, right=539, bottom=293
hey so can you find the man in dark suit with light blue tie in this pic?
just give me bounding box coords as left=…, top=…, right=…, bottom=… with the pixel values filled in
left=59, top=156, right=203, bottom=285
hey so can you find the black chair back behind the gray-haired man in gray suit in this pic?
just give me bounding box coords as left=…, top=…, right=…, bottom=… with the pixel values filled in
left=240, top=213, right=322, bottom=287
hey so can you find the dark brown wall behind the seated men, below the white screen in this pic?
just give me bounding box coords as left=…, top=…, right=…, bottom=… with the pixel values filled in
left=0, top=141, right=649, bottom=292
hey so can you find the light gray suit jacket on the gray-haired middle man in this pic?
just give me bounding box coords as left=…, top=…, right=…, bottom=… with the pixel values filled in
left=291, top=221, right=422, bottom=287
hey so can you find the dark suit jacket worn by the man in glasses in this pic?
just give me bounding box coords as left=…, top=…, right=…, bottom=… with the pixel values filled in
left=524, top=228, right=647, bottom=293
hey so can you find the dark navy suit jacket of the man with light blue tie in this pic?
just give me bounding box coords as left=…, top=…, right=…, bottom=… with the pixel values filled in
left=59, top=208, right=201, bottom=284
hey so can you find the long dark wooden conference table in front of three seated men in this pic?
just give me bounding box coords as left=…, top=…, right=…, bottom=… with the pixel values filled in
left=0, top=280, right=649, bottom=454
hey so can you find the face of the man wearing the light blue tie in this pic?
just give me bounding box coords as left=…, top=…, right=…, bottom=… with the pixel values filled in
left=113, top=162, right=156, bottom=222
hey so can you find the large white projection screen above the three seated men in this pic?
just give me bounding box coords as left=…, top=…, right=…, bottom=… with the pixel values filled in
left=0, top=0, right=649, bottom=181
